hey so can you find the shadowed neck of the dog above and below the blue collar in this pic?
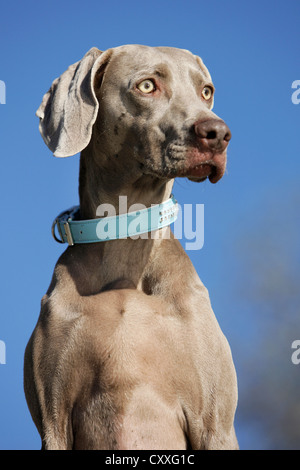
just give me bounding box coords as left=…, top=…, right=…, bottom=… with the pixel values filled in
left=71, top=151, right=173, bottom=295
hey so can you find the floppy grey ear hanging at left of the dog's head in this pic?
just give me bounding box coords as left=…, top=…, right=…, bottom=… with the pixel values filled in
left=36, top=47, right=112, bottom=157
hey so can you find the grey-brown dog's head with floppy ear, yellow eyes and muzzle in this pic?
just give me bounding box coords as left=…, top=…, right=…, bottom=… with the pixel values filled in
left=37, top=45, right=231, bottom=183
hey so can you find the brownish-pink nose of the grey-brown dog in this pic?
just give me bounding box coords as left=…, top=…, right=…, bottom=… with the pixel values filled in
left=194, top=119, right=231, bottom=153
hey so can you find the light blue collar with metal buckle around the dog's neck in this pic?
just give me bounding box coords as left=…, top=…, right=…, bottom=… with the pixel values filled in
left=52, top=194, right=178, bottom=246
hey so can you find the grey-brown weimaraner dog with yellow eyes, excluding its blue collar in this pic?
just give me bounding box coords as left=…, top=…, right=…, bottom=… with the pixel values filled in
left=24, top=45, right=238, bottom=450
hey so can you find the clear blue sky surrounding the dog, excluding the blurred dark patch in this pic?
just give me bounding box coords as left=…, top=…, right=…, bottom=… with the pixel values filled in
left=0, top=0, right=300, bottom=449
